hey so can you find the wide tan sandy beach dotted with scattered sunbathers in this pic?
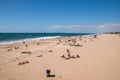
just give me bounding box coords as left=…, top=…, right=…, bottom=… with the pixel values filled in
left=0, top=34, right=120, bottom=80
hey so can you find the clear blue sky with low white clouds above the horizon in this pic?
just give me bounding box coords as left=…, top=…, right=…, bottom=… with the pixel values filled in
left=0, top=0, right=120, bottom=33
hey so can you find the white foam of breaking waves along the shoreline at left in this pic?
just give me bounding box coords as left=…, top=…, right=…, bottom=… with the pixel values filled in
left=0, top=36, right=61, bottom=45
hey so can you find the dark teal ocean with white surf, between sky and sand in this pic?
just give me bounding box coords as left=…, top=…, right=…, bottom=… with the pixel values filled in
left=0, top=33, right=93, bottom=45
